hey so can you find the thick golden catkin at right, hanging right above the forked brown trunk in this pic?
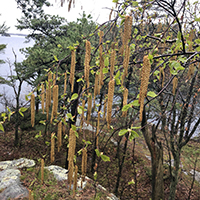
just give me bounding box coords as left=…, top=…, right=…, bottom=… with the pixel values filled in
left=139, top=56, right=151, bottom=121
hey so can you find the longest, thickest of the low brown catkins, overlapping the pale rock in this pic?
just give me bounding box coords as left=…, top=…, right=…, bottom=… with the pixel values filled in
left=68, top=128, right=76, bottom=188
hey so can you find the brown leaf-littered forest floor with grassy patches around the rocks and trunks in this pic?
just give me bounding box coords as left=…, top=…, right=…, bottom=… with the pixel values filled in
left=0, top=116, right=200, bottom=200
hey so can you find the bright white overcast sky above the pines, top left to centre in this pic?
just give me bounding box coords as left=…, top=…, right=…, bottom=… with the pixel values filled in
left=0, top=0, right=115, bottom=33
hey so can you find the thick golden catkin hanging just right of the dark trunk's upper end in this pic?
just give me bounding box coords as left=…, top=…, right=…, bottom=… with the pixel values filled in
left=84, top=40, right=91, bottom=88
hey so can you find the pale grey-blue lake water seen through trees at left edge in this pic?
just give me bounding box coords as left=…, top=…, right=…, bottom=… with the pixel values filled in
left=0, top=35, right=34, bottom=112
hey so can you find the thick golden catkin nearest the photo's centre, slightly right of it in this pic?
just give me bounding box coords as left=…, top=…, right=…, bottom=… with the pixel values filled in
left=107, top=79, right=115, bottom=129
